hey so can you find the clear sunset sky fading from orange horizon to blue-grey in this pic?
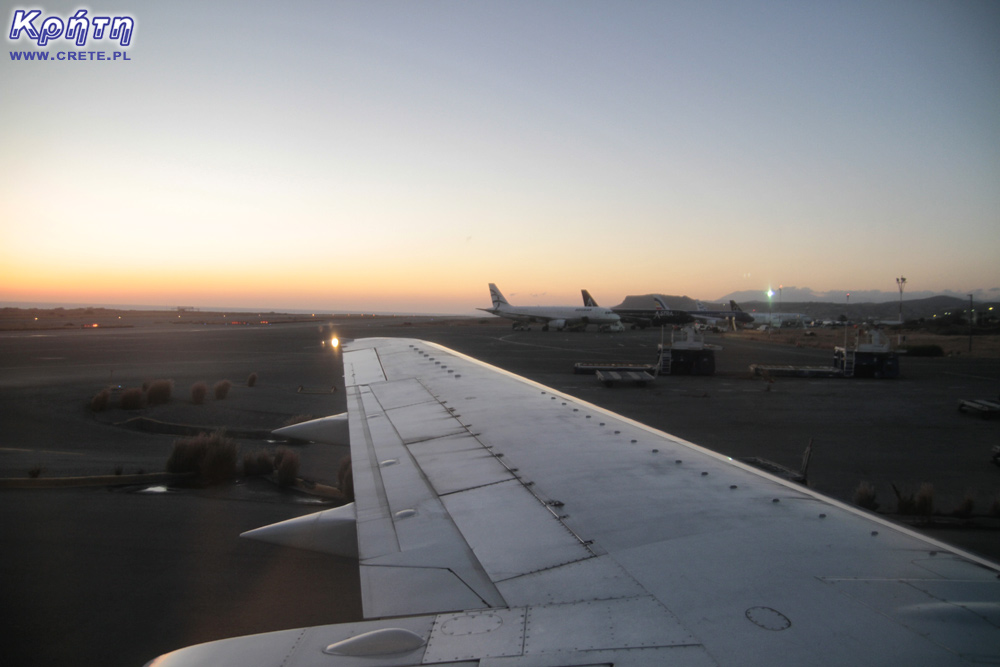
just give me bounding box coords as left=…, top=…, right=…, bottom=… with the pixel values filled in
left=0, top=0, right=1000, bottom=312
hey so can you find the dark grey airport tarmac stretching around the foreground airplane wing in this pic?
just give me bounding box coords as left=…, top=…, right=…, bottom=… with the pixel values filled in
left=0, top=318, right=1000, bottom=665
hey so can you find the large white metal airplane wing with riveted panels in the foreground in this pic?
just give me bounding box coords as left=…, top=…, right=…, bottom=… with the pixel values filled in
left=152, top=339, right=1000, bottom=667
